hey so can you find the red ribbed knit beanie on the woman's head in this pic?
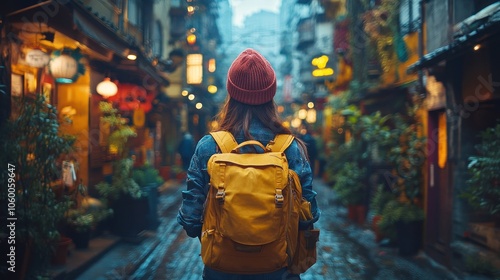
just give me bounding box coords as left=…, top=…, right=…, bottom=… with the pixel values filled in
left=227, top=49, right=276, bottom=105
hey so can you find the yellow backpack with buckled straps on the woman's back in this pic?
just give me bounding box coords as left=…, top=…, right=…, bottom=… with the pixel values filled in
left=201, top=131, right=319, bottom=274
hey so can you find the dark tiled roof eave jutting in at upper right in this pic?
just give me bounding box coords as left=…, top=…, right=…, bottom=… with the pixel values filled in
left=407, top=7, right=500, bottom=74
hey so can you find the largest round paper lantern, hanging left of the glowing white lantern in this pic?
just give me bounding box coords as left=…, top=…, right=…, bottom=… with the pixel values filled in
left=49, top=48, right=85, bottom=84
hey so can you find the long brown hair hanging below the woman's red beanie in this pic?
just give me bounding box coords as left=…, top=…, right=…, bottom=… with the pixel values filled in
left=215, top=96, right=307, bottom=157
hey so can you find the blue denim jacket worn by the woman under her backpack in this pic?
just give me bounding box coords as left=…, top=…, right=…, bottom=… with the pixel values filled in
left=177, top=120, right=320, bottom=240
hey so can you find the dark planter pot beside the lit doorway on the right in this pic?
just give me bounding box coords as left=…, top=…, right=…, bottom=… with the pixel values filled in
left=396, top=221, right=423, bottom=256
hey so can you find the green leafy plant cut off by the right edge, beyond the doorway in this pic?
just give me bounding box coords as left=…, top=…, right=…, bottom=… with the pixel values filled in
left=460, top=121, right=500, bottom=215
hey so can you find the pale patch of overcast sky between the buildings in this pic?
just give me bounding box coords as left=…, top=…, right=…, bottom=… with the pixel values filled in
left=229, top=0, right=281, bottom=26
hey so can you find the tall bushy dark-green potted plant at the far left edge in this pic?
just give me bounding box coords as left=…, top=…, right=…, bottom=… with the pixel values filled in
left=0, top=95, right=75, bottom=279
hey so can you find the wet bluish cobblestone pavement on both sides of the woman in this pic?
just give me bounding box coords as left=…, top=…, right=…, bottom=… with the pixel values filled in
left=78, top=180, right=458, bottom=280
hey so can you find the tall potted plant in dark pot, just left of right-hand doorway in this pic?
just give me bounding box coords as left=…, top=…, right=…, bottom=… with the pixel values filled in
left=379, top=104, right=426, bottom=255
